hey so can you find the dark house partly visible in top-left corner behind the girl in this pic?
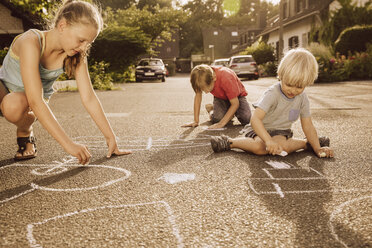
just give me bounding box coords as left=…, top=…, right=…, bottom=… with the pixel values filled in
left=0, top=0, right=42, bottom=49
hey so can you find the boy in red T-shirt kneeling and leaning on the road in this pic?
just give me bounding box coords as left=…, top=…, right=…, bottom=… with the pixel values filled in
left=182, top=65, right=251, bottom=129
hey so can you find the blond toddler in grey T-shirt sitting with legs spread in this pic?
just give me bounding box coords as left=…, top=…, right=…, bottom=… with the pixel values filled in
left=211, top=48, right=334, bottom=157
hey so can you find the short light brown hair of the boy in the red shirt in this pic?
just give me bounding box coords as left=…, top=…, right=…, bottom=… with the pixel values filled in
left=190, top=64, right=214, bottom=92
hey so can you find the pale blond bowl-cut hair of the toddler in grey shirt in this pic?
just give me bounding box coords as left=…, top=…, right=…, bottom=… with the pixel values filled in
left=278, top=48, right=318, bottom=88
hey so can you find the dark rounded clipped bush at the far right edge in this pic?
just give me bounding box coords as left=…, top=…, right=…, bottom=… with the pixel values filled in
left=335, top=25, right=372, bottom=55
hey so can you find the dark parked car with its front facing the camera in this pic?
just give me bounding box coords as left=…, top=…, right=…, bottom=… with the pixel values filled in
left=135, top=58, right=167, bottom=82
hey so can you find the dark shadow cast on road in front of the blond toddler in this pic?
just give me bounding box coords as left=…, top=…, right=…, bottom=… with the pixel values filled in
left=232, top=151, right=367, bottom=247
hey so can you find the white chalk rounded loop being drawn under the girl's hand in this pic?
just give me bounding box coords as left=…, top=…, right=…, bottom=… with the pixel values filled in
left=0, top=157, right=131, bottom=203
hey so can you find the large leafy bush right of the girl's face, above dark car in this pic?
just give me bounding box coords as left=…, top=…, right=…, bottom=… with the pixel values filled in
left=91, top=6, right=182, bottom=71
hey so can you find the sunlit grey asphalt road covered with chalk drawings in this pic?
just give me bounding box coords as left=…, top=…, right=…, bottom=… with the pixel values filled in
left=0, top=75, right=372, bottom=248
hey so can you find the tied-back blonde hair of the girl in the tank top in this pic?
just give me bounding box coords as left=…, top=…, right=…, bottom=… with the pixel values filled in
left=52, top=0, right=103, bottom=78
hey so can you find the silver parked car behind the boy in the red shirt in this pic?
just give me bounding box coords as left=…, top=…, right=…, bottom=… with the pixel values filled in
left=228, top=55, right=259, bottom=79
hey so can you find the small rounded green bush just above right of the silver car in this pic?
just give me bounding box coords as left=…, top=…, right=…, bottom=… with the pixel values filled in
left=242, top=41, right=275, bottom=65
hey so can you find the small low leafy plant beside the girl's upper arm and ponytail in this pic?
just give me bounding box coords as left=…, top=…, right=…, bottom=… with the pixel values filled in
left=89, top=61, right=114, bottom=90
